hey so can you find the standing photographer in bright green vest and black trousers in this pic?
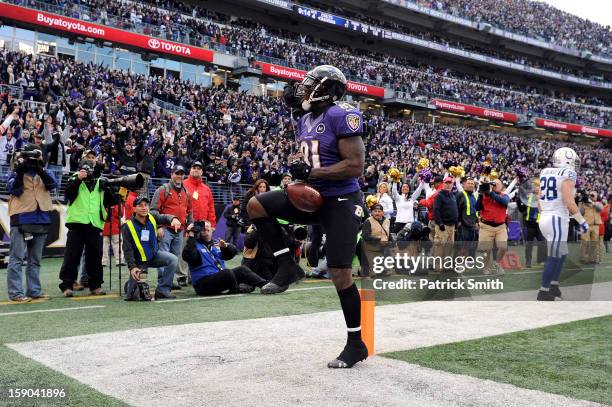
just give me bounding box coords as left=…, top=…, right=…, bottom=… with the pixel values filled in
left=59, top=160, right=119, bottom=297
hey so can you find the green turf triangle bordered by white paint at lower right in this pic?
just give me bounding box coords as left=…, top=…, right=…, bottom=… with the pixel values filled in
left=383, top=316, right=612, bottom=404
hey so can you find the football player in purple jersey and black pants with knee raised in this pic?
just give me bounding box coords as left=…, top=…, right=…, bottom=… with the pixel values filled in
left=247, top=65, right=368, bottom=368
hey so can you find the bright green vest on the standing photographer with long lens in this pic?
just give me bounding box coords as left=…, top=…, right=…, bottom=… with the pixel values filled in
left=66, top=180, right=106, bottom=230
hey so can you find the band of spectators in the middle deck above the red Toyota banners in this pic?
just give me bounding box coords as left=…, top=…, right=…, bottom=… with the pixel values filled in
left=13, top=0, right=612, bottom=127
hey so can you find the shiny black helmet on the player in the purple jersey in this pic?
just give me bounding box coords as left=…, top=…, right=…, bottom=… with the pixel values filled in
left=295, top=65, right=347, bottom=112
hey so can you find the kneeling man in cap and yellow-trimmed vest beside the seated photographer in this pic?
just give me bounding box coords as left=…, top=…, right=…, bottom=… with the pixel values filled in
left=121, top=196, right=182, bottom=300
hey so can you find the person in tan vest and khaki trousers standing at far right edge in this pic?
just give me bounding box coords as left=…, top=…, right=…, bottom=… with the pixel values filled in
left=578, top=191, right=603, bottom=264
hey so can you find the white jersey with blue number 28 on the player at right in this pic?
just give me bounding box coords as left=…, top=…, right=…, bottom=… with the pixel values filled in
left=540, top=168, right=576, bottom=218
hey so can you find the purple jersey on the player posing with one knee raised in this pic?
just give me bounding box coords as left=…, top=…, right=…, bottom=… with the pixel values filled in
left=297, top=102, right=363, bottom=196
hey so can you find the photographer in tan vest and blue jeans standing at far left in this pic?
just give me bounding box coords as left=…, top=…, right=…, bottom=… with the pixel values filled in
left=6, top=144, right=57, bottom=302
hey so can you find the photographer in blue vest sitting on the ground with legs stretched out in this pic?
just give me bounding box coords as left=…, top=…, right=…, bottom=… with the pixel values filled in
left=183, top=221, right=268, bottom=295
